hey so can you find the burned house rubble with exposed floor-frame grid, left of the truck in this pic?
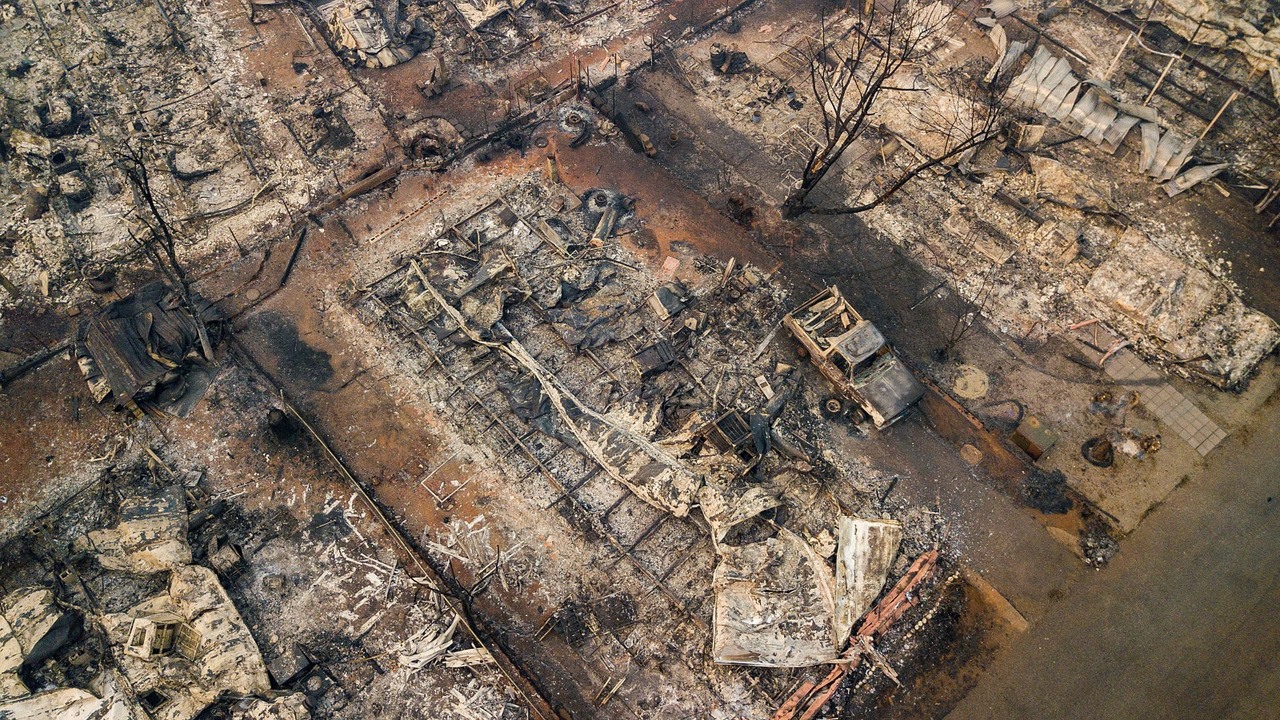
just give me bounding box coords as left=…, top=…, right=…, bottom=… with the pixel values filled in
left=360, top=165, right=943, bottom=712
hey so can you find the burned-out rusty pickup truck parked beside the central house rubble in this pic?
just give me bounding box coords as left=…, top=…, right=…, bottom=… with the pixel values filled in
left=782, top=287, right=924, bottom=428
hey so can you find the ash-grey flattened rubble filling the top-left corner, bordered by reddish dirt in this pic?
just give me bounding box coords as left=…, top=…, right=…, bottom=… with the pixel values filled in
left=0, top=3, right=387, bottom=322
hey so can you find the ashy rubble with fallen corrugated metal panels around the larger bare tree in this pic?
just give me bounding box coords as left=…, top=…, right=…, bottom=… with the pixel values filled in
left=660, top=4, right=1280, bottom=388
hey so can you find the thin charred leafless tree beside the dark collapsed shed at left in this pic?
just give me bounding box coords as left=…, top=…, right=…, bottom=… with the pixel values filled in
left=115, top=143, right=214, bottom=363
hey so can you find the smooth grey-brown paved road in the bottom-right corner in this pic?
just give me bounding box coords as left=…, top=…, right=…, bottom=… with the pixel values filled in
left=948, top=396, right=1280, bottom=720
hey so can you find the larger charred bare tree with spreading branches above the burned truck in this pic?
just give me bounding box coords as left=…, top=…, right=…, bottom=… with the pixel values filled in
left=782, top=0, right=1005, bottom=218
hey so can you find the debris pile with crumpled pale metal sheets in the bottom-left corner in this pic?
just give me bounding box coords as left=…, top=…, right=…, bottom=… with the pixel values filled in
left=0, top=476, right=310, bottom=720
